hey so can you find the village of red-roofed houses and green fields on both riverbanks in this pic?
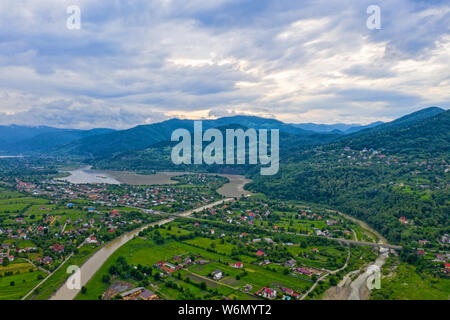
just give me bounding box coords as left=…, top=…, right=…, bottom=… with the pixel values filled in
left=0, top=168, right=450, bottom=300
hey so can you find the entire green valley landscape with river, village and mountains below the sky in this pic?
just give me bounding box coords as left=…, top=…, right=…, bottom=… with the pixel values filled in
left=0, top=108, right=450, bottom=300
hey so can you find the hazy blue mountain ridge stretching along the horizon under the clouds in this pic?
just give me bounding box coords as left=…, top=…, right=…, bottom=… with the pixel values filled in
left=0, top=107, right=444, bottom=158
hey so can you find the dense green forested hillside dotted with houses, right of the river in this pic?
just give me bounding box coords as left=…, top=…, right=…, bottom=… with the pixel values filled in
left=249, top=111, right=450, bottom=244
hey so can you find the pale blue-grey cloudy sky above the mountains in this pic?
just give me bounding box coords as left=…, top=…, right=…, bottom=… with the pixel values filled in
left=0, top=0, right=450, bottom=128
